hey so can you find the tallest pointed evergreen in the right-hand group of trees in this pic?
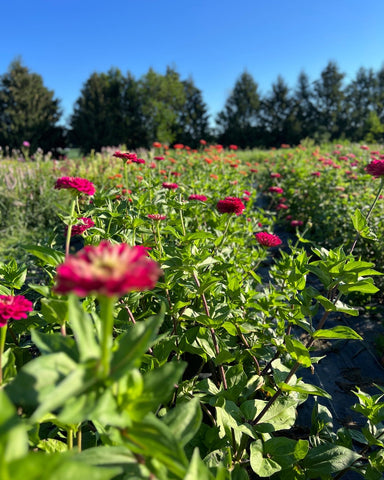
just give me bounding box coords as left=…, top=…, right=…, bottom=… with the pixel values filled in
left=315, top=62, right=347, bottom=140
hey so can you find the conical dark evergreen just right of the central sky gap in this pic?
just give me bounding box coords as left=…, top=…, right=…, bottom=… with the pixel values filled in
left=216, top=72, right=260, bottom=148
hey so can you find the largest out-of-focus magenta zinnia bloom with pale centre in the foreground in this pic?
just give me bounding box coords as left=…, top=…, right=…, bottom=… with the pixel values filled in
left=55, top=241, right=161, bottom=297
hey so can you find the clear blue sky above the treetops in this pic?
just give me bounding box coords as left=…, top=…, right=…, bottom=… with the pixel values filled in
left=0, top=0, right=384, bottom=126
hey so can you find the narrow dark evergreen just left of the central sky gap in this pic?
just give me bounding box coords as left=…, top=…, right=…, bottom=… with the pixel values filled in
left=176, top=79, right=211, bottom=148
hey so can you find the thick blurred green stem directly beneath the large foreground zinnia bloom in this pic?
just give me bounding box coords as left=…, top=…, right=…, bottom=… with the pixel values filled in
left=98, top=296, right=116, bottom=377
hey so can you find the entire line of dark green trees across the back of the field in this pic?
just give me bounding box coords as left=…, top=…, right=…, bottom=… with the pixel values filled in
left=0, top=60, right=384, bottom=153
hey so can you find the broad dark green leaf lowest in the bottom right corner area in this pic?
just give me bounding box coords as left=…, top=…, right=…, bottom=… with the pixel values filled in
left=302, top=444, right=361, bottom=478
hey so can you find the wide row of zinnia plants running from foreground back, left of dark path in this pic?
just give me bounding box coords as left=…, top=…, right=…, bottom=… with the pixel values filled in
left=0, top=143, right=384, bottom=480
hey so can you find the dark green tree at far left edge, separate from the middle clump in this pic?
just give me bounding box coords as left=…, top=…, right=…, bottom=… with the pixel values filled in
left=0, top=60, right=64, bottom=152
